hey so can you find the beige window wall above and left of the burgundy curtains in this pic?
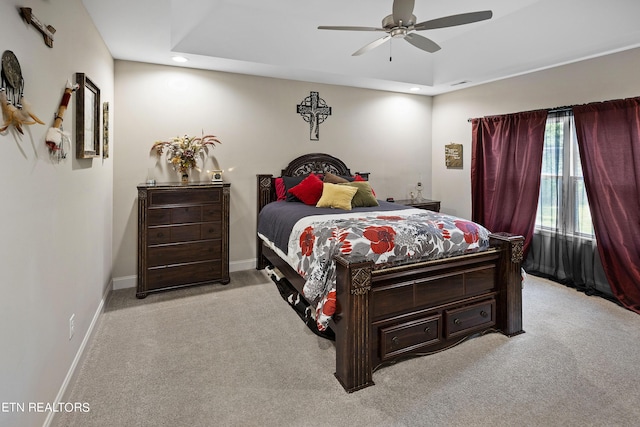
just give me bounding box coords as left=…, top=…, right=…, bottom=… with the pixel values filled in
left=432, top=49, right=640, bottom=219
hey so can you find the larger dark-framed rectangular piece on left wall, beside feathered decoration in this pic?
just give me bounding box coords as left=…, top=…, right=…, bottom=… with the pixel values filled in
left=76, top=73, right=100, bottom=159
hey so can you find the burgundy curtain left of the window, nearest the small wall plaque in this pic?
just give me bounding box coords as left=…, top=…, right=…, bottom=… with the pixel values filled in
left=471, top=110, right=547, bottom=253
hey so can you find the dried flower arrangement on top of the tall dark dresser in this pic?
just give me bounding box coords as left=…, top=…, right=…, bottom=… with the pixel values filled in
left=151, top=135, right=222, bottom=176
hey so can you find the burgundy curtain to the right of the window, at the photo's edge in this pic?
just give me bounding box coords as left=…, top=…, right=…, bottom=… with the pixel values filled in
left=573, top=98, right=640, bottom=313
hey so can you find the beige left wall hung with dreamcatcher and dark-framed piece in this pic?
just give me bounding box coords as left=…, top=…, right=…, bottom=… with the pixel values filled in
left=0, top=0, right=113, bottom=426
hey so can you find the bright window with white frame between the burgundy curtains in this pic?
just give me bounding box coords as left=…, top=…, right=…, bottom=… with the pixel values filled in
left=536, top=111, right=595, bottom=239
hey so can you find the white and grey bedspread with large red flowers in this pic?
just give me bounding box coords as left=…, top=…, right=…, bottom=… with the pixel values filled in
left=287, top=209, right=489, bottom=331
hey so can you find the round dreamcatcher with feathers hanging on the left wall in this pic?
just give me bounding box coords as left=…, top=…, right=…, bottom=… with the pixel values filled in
left=0, top=50, right=44, bottom=134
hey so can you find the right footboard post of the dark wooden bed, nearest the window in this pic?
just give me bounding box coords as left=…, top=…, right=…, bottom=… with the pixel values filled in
left=489, top=233, right=524, bottom=337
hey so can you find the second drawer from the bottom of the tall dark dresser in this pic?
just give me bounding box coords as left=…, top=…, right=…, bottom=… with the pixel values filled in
left=147, top=239, right=222, bottom=267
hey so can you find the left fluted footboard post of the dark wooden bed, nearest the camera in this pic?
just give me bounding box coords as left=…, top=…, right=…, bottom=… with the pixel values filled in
left=333, top=256, right=374, bottom=393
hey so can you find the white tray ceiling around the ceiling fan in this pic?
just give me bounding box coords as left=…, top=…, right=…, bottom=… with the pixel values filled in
left=83, top=0, right=640, bottom=95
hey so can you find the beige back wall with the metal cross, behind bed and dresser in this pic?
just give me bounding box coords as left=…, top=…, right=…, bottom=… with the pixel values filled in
left=114, top=61, right=431, bottom=287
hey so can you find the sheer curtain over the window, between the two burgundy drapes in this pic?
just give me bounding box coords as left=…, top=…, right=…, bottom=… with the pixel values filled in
left=522, top=110, right=617, bottom=302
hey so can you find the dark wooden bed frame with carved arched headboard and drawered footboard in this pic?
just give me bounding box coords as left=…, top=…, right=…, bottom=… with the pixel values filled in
left=256, top=153, right=524, bottom=392
